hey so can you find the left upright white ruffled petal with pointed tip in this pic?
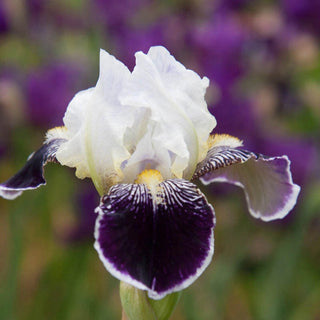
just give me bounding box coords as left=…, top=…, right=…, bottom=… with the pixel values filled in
left=57, top=50, right=138, bottom=192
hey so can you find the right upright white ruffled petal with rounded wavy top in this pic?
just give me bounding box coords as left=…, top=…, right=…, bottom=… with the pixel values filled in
left=120, top=47, right=216, bottom=179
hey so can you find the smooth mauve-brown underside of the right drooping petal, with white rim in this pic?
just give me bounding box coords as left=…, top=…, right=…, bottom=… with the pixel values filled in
left=200, top=154, right=300, bottom=221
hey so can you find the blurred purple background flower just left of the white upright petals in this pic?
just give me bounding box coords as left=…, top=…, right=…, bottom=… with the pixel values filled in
left=26, top=63, right=82, bottom=127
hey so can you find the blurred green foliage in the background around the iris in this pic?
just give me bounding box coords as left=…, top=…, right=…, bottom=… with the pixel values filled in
left=0, top=0, right=320, bottom=320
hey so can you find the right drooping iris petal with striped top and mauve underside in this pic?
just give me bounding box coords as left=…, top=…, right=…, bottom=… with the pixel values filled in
left=194, top=137, right=300, bottom=221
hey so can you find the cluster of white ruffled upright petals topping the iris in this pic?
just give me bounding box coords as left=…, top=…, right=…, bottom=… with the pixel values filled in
left=49, top=46, right=216, bottom=192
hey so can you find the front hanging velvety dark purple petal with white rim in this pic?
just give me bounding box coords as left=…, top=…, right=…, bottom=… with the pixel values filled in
left=95, top=179, right=215, bottom=299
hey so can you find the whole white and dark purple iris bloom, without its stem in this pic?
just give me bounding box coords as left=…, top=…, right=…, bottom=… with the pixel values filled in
left=0, top=46, right=300, bottom=299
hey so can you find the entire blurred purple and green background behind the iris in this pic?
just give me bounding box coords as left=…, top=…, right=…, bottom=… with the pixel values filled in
left=0, top=0, right=320, bottom=320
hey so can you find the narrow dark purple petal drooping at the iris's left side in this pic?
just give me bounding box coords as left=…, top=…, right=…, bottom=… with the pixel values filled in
left=0, top=139, right=65, bottom=200
